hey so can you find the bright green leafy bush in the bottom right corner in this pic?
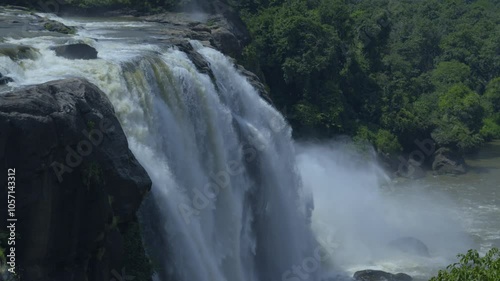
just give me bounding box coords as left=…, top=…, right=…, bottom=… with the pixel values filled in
left=429, top=248, right=500, bottom=281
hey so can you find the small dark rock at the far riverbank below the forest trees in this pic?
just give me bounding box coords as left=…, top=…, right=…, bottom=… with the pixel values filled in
left=432, top=147, right=467, bottom=175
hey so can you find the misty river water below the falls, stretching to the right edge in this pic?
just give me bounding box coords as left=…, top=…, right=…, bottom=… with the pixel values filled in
left=298, top=141, right=500, bottom=280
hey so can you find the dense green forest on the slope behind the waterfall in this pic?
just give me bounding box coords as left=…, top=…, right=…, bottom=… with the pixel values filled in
left=234, top=0, right=500, bottom=155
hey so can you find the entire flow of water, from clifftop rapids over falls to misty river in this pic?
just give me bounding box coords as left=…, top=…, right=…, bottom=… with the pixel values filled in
left=0, top=9, right=500, bottom=281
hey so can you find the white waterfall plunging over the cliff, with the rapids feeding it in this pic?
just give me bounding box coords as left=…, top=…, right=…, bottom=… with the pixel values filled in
left=0, top=20, right=320, bottom=281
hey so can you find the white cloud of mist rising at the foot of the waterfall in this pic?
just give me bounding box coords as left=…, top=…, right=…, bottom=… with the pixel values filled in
left=296, top=142, right=473, bottom=278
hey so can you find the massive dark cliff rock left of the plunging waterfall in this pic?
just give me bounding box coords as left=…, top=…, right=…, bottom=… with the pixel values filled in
left=0, top=79, right=151, bottom=281
